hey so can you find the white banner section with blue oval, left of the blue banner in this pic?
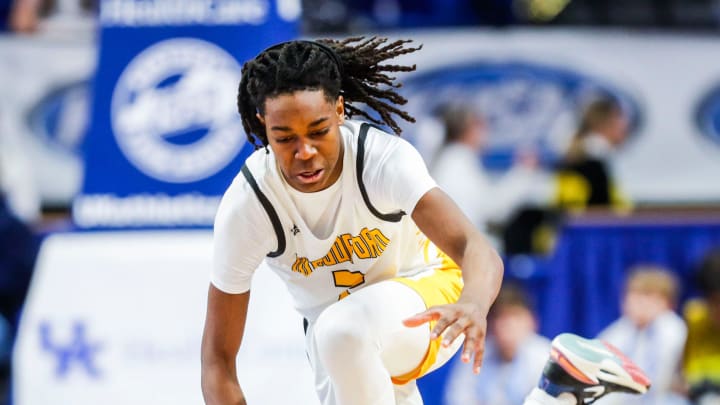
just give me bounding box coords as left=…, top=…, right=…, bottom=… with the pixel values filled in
left=0, top=32, right=96, bottom=220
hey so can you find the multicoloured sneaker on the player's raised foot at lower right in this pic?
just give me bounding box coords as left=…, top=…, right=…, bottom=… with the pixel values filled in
left=539, top=333, right=650, bottom=404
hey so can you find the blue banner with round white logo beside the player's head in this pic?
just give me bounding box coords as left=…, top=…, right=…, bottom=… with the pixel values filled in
left=73, top=0, right=300, bottom=228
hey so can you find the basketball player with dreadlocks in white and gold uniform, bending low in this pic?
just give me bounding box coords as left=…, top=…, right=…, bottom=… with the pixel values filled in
left=202, top=38, right=646, bottom=405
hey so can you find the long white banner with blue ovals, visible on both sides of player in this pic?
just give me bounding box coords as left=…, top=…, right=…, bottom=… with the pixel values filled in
left=0, top=28, right=720, bottom=211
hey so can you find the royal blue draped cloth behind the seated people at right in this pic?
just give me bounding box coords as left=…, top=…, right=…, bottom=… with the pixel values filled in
left=419, top=217, right=720, bottom=405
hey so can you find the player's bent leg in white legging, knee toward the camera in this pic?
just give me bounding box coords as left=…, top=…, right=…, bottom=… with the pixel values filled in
left=308, top=281, right=430, bottom=405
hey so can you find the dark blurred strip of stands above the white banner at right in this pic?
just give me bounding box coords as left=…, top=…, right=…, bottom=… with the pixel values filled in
left=303, top=0, right=720, bottom=33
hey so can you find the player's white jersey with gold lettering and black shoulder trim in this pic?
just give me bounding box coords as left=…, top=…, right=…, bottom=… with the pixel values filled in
left=212, top=120, right=447, bottom=321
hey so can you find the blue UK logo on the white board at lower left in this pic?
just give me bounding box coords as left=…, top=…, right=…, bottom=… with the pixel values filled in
left=40, top=321, right=102, bottom=378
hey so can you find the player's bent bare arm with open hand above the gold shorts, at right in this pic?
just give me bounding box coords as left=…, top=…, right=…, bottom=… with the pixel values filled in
left=405, top=188, right=503, bottom=373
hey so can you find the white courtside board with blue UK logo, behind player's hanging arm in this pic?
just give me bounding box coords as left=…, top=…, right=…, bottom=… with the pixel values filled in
left=13, top=231, right=318, bottom=405
